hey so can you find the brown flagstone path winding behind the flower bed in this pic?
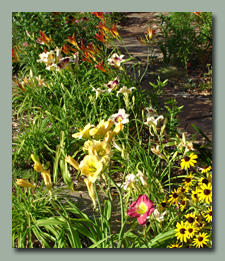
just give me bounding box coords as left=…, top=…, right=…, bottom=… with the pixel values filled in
left=115, top=12, right=212, bottom=143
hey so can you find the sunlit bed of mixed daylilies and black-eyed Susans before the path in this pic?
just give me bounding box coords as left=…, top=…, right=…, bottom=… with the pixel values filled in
left=12, top=12, right=212, bottom=248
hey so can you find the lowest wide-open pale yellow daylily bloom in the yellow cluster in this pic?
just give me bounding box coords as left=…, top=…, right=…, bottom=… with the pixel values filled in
left=79, top=155, right=103, bottom=183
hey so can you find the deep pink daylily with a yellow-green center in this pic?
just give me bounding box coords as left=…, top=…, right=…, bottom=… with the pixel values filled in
left=127, top=195, right=155, bottom=226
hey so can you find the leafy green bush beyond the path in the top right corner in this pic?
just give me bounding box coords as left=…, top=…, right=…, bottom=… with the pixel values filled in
left=159, top=12, right=212, bottom=67
